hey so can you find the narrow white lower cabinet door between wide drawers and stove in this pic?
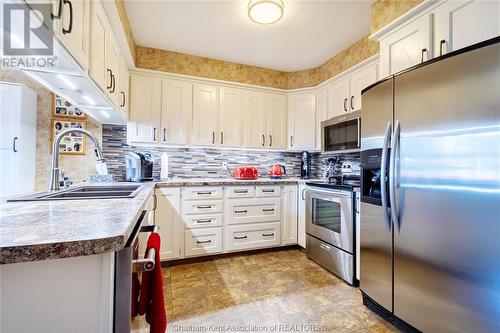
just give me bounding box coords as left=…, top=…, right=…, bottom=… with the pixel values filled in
left=281, top=185, right=298, bottom=245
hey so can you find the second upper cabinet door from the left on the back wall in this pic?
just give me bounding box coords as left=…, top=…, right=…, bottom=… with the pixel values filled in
left=160, top=79, right=193, bottom=144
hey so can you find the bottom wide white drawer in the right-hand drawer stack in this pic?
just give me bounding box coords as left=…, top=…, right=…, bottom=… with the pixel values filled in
left=224, top=222, right=281, bottom=251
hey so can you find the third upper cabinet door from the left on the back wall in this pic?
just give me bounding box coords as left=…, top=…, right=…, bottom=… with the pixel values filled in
left=191, top=84, right=219, bottom=146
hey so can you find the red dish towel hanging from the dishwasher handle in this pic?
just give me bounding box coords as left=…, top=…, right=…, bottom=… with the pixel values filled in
left=139, top=232, right=167, bottom=333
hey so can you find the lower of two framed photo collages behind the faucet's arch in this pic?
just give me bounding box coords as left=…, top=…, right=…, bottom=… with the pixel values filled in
left=50, top=117, right=87, bottom=155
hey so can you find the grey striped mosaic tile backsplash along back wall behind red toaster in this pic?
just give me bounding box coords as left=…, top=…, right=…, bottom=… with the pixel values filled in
left=103, top=125, right=300, bottom=180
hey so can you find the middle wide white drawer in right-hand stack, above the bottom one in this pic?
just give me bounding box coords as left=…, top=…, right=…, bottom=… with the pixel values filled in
left=224, top=198, right=281, bottom=225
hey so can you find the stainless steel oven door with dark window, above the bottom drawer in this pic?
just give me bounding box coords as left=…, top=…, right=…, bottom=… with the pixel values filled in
left=306, top=186, right=354, bottom=253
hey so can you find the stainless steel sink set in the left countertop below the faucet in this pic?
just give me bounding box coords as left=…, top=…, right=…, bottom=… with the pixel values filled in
left=7, top=184, right=143, bottom=202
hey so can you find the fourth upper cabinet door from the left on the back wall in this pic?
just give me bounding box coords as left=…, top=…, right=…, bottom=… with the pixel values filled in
left=218, top=87, right=243, bottom=147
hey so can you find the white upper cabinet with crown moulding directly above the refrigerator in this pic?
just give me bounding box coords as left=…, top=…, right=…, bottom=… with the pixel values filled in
left=370, top=0, right=500, bottom=77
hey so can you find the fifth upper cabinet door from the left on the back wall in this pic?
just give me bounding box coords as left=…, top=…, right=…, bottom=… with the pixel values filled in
left=242, top=91, right=271, bottom=148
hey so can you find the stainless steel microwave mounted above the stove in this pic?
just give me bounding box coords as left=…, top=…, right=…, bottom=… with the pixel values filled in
left=321, top=111, right=361, bottom=153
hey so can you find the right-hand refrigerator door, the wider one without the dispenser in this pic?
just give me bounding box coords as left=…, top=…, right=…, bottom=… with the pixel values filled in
left=393, top=43, right=500, bottom=332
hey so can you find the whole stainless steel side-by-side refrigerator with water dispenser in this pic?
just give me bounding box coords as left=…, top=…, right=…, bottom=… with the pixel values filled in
left=360, top=37, right=500, bottom=332
